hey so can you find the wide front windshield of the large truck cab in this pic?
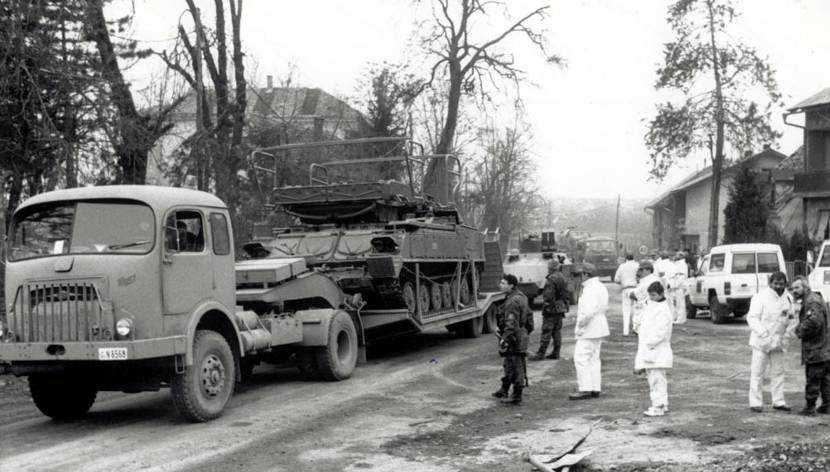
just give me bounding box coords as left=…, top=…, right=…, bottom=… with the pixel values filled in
left=8, top=201, right=155, bottom=261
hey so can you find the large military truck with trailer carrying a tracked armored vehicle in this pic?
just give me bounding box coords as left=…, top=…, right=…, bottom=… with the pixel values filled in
left=0, top=138, right=504, bottom=421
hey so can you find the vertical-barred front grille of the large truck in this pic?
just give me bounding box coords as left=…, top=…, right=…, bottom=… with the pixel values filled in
left=8, top=282, right=115, bottom=342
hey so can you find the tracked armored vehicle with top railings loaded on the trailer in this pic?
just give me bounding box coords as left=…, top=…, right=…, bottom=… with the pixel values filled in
left=244, top=138, right=498, bottom=340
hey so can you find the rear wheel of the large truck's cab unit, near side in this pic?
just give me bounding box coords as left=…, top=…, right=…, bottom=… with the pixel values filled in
left=317, top=311, right=358, bottom=380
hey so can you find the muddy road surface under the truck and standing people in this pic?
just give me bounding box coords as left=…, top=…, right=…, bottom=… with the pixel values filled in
left=0, top=284, right=827, bottom=472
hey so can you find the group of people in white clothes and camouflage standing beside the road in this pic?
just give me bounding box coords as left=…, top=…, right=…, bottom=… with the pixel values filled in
left=493, top=252, right=830, bottom=416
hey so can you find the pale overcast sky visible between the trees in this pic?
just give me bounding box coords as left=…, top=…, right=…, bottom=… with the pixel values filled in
left=117, top=0, right=830, bottom=198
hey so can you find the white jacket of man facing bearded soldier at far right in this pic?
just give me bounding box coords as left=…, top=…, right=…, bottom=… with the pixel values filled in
left=746, top=287, right=798, bottom=352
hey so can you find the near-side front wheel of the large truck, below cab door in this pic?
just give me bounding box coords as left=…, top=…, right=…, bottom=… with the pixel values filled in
left=170, top=330, right=236, bottom=423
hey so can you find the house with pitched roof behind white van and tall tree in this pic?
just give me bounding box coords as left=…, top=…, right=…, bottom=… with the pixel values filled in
left=645, top=147, right=788, bottom=252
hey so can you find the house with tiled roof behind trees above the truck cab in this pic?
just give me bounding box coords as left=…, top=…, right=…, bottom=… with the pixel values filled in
left=147, top=76, right=369, bottom=185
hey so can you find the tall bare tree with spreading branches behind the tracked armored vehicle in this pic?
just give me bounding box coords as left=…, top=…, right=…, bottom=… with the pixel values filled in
left=421, top=0, right=562, bottom=201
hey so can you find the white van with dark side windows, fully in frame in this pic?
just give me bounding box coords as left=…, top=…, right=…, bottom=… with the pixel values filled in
left=686, top=244, right=788, bottom=323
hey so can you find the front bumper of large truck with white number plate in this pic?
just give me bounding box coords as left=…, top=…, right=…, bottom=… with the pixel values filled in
left=0, top=336, right=187, bottom=364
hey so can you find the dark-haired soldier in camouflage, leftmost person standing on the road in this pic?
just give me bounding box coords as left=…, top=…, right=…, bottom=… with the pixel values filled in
left=493, top=274, right=533, bottom=404
